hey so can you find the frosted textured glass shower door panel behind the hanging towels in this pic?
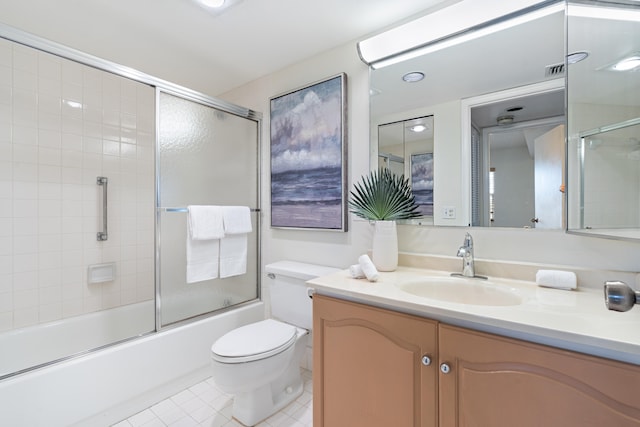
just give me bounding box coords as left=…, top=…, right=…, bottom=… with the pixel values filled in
left=157, top=91, right=260, bottom=326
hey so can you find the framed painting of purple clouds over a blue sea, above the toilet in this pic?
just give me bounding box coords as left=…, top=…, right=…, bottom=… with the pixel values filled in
left=270, top=73, right=347, bottom=231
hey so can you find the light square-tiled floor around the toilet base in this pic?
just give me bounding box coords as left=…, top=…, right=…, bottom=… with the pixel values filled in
left=113, top=369, right=313, bottom=427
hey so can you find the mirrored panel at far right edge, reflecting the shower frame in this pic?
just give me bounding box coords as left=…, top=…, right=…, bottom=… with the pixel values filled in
left=567, top=1, right=640, bottom=239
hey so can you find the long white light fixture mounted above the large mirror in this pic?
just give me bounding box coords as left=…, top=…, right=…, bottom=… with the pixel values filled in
left=358, top=0, right=565, bottom=69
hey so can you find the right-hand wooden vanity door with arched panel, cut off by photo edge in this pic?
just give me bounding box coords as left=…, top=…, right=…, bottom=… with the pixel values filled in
left=438, top=325, right=640, bottom=427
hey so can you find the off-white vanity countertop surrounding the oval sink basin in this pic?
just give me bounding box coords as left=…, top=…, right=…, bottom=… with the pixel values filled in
left=307, top=266, right=640, bottom=365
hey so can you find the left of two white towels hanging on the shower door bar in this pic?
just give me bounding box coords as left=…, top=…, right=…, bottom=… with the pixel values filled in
left=187, top=205, right=224, bottom=283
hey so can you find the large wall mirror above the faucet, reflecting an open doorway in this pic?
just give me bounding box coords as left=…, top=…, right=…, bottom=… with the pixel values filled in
left=370, top=2, right=566, bottom=229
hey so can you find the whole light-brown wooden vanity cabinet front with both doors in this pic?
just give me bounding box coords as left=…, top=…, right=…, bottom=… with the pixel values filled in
left=313, top=295, right=640, bottom=427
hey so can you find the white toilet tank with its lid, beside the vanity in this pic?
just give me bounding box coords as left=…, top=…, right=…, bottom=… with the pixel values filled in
left=265, top=261, right=339, bottom=329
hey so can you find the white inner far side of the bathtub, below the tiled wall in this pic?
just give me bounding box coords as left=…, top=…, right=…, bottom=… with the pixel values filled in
left=0, top=300, right=155, bottom=377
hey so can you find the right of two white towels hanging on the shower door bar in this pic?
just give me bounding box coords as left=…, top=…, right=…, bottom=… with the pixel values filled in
left=220, top=206, right=252, bottom=278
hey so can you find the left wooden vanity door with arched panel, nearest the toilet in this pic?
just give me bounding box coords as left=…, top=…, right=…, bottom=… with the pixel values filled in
left=313, top=295, right=438, bottom=427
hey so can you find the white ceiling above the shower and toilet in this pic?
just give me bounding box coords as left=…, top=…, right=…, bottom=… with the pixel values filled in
left=0, top=0, right=450, bottom=96
